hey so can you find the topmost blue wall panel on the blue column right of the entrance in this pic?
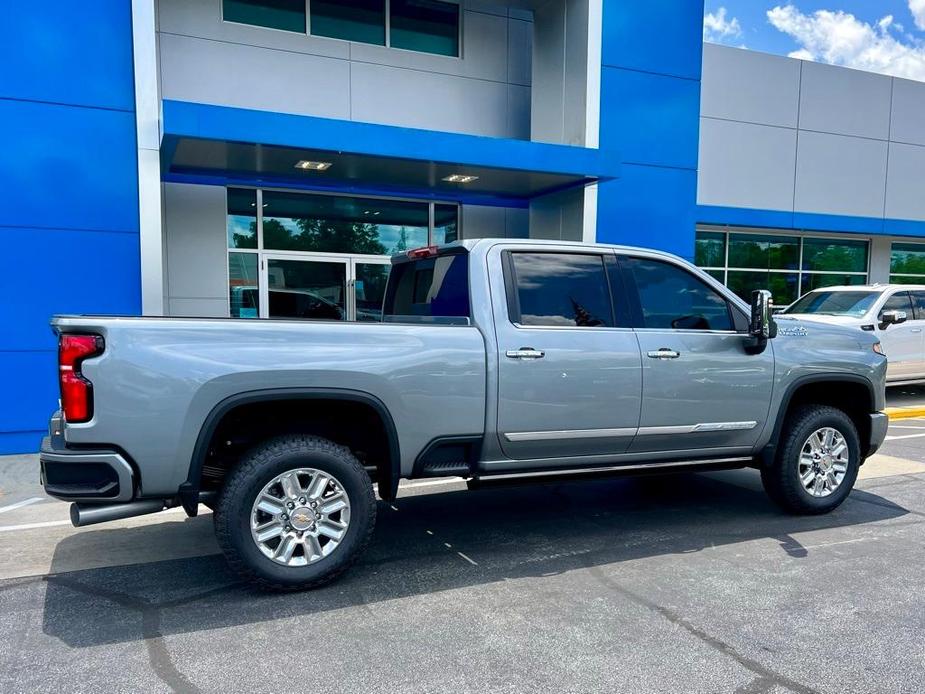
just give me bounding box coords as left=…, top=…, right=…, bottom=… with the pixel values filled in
left=602, top=0, right=703, bottom=80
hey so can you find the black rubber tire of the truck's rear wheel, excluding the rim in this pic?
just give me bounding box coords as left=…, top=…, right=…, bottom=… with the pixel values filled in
left=214, top=434, right=376, bottom=591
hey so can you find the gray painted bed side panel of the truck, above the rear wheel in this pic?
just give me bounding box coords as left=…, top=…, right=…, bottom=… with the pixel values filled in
left=56, top=317, right=485, bottom=496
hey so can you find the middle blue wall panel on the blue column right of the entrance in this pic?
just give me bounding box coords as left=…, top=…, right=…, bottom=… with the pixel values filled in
left=601, top=66, right=700, bottom=169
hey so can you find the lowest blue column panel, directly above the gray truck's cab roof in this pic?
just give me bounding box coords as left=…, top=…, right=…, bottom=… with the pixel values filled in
left=597, top=164, right=697, bottom=260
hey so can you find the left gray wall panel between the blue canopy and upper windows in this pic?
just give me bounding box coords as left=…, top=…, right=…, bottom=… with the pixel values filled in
left=160, top=32, right=350, bottom=118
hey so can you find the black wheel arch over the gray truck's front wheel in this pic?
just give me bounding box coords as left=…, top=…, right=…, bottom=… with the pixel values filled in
left=758, top=374, right=876, bottom=466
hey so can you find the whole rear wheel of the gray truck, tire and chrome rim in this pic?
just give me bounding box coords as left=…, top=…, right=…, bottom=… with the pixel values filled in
left=215, top=435, right=376, bottom=590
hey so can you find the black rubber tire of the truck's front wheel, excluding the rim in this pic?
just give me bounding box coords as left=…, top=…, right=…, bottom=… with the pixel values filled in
left=761, top=405, right=861, bottom=515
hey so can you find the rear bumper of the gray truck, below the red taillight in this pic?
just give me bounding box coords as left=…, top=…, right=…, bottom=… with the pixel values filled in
left=39, top=413, right=135, bottom=503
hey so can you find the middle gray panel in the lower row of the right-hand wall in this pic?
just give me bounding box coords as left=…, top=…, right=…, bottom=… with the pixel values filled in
left=794, top=131, right=887, bottom=217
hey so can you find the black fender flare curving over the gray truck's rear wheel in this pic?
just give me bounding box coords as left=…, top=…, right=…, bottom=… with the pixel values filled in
left=179, top=388, right=401, bottom=516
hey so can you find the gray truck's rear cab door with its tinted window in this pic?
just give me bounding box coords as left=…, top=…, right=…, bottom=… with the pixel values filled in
left=489, top=246, right=642, bottom=460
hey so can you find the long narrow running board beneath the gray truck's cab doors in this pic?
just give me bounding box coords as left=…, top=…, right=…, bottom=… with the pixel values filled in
left=466, top=456, right=754, bottom=490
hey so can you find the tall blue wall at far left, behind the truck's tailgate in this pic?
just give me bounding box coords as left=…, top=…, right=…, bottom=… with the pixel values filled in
left=0, top=0, right=141, bottom=454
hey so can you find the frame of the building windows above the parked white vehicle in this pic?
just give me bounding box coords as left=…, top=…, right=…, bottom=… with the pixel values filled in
left=694, top=224, right=868, bottom=305
